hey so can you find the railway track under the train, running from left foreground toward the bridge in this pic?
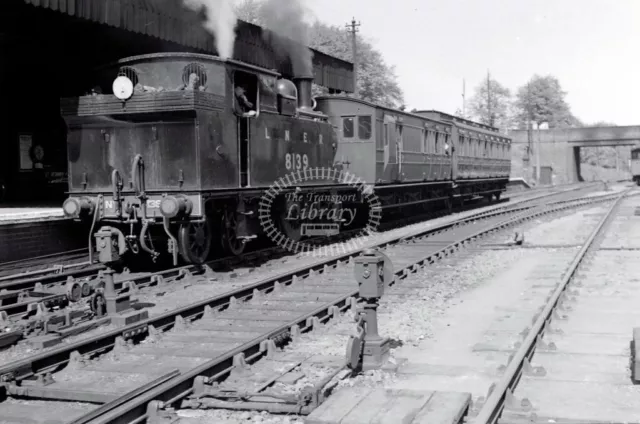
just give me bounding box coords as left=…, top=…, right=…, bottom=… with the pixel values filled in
left=0, top=186, right=612, bottom=348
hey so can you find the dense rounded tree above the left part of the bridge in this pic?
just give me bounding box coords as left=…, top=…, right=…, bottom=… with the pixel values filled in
left=515, top=75, right=580, bottom=129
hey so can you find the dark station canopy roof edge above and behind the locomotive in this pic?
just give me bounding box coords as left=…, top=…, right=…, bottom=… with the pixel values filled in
left=18, top=0, right=353, bottom=92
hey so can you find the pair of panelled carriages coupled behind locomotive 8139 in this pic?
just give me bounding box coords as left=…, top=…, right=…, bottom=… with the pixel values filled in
left=316, top=96, right=511, bottom=214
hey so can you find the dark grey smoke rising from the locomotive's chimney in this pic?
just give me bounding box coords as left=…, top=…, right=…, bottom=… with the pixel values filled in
left=260, top=0, right=313, bottom=76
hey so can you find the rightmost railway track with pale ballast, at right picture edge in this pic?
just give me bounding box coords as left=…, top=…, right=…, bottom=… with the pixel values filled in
left=469, top=188, right=640, bottom=424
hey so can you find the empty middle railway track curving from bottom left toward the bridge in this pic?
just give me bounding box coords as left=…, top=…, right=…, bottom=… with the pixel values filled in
left=0, top=186, right=615, bottom=423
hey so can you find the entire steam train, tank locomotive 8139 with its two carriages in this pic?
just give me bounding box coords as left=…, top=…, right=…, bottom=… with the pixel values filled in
left=61, top=53, right=510, bottom=264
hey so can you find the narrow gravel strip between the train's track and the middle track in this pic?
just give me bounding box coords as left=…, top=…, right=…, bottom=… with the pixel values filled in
left=0, top=193, right=564, bottom=364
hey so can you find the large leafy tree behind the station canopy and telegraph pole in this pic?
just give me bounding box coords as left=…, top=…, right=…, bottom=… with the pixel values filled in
left=236, top=0, right=404, bottom=107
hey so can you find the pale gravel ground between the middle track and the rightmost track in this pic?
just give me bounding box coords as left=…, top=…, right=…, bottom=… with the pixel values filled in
left=171, top=207, right=603, bottom=424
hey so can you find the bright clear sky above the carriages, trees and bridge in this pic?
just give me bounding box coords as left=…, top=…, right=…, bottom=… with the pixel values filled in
left=303, top=0, right=640, bottom=125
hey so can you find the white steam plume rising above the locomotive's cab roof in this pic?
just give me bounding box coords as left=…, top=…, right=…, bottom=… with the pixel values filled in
left=183, top=0, right=238, bottom=59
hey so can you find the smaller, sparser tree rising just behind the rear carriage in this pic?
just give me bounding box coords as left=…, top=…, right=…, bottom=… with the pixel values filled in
left=469, top=76, right=511, bottom=128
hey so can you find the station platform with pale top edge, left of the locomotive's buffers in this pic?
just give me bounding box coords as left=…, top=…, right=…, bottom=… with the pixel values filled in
left=0, top=205, right=88, bottom=265
